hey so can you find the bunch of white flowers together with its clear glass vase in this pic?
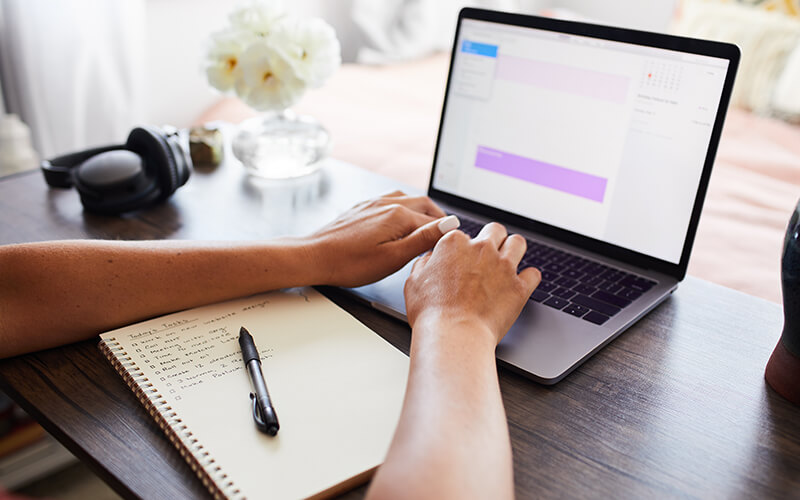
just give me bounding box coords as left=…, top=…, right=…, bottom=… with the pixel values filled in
left=205, top=2, right=341, bottom=178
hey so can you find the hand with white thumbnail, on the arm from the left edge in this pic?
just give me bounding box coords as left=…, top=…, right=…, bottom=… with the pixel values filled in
left=309, top=191, right=458, bottom=287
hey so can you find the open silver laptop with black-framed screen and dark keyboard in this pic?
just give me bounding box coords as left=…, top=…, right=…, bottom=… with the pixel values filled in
left=353, top=8, right=740, bottom=384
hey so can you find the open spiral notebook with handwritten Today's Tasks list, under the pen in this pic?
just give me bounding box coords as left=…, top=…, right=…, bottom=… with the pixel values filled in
left=100, top=288, right=408, bottom=499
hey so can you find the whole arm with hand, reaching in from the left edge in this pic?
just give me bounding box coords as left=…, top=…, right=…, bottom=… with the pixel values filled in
left=0, top=192, right=456, bottom=358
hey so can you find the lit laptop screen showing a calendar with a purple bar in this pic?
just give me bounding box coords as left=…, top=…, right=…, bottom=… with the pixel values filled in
left=431, top=19, right=729, bottom=264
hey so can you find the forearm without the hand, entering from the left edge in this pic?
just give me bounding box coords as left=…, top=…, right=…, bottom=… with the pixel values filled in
left=0, top=239, right=319, bottom=358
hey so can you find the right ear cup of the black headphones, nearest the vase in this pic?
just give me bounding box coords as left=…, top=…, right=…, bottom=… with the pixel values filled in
left=126, top=126, right=190, bottom=201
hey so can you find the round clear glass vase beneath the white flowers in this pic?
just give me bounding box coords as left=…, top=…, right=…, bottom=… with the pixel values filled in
left=232, top=109, right=330, bottom=179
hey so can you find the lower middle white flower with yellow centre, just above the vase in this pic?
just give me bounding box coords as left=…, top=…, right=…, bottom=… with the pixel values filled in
left=237, top=41, right=306, bottom=111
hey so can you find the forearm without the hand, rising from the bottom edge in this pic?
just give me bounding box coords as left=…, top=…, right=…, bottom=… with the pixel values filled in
left=370, top=319, right=514, bottom=499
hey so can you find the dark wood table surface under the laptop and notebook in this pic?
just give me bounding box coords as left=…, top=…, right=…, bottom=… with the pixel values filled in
left=0, top=157, right=800, bottom=499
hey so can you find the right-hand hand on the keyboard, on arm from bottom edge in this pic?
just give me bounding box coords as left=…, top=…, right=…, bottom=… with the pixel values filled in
left=405, top=222, right=541, bottom=347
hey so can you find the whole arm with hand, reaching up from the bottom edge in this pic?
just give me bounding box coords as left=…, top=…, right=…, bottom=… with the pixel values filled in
left=368, top=224, right=541, bottom=499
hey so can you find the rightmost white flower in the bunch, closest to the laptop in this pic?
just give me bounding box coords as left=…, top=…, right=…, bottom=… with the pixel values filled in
left=273, top=18, right=342, bottom=88
